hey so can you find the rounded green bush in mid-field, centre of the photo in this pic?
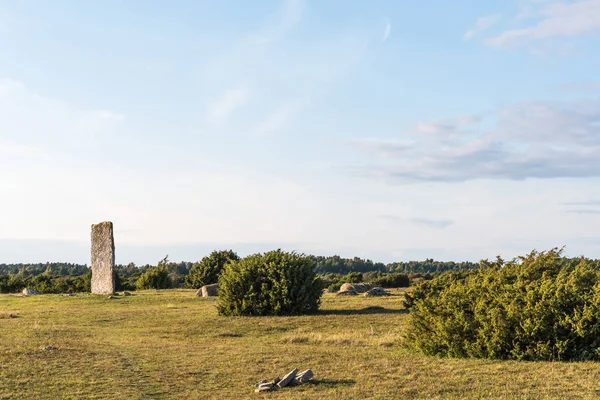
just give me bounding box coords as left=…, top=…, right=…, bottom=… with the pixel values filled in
left=217, top=250, right=322, bottom=315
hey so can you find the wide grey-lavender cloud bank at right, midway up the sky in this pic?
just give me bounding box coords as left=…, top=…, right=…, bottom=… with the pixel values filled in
left=349, top=101, right=600, bottom=183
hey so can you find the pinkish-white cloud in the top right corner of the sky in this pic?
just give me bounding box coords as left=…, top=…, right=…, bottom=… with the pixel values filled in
left=485, top=0, right=600, bottom=47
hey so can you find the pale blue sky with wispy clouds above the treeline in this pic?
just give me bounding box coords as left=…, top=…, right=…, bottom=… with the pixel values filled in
left=0, top=0, right=600, bottom=264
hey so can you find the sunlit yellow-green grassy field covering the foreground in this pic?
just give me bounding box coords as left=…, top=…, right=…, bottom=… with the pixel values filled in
left=0, top=290, right=600, bottom=399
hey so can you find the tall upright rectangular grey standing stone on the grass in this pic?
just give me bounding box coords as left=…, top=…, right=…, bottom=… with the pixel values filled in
left=92, top=222, right=115, bottom=294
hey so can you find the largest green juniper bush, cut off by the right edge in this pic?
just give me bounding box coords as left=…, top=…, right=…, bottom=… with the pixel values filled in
left=406, top=249, right=600, bottom=360
